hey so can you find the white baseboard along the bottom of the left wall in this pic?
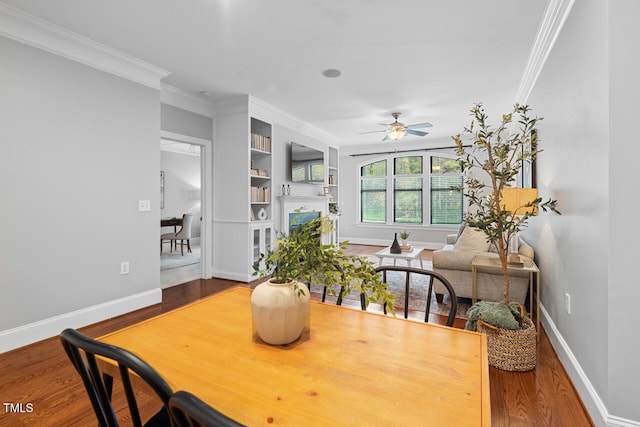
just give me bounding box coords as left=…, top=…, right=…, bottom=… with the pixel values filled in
left=0, top=288, right=162, bottom=353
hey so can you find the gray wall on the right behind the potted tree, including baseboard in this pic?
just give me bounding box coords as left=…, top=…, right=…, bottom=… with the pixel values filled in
left=525, top=0, right=640, bottom=425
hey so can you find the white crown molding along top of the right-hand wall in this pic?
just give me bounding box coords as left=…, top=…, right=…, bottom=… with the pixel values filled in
left=516, top=0, right=575, bottom=104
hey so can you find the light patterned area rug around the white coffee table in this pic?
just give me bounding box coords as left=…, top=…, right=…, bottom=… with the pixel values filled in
left=311, top=257, right=471, bottom=319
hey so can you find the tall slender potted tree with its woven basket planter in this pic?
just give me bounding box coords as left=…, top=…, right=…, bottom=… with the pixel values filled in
left=453, top=103, right=560, bottom=370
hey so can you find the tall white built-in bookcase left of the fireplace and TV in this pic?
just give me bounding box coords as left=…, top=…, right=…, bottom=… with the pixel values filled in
left=213, top=101, right=274, bottom=282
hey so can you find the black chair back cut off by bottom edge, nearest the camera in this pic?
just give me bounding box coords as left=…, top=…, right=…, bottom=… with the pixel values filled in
left=169, top=391, right=244, bottom=427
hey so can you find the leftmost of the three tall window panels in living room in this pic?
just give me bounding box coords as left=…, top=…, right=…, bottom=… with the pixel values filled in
left=360, top=160, right=387, bottom=223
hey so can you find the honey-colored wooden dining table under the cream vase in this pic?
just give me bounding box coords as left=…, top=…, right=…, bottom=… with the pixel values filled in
left=99, top=287, right=491, bottom=427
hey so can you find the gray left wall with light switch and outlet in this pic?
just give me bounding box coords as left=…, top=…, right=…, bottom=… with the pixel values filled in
left=0, top=37, right=160, bottom=351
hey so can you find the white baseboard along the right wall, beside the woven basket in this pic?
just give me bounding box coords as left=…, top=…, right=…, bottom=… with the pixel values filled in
left=540, top=305, right=640, bottom=427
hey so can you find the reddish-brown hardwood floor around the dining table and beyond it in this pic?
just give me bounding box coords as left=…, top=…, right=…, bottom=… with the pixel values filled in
left=0, top=245, right=593, bottom=427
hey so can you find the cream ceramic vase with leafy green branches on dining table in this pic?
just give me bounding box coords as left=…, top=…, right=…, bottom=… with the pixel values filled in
left=251, top=212, right=395, bottom=344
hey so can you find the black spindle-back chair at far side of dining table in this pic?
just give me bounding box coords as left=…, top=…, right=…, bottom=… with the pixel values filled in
left=376, top=265, right=458, bottom=326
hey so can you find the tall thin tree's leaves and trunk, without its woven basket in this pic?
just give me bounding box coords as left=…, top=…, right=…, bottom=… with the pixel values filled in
left=452, top=103, right=560, bottom=329
